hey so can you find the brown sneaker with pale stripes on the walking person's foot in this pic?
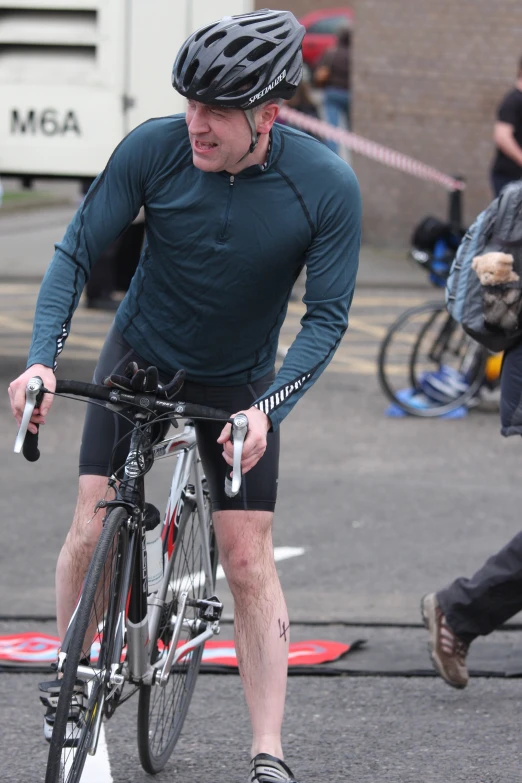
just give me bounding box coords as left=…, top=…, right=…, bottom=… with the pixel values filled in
left=421, top=593, right=469, bottom=688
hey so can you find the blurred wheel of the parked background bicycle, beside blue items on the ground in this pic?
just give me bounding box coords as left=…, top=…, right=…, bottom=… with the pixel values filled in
left=378, top=302, right=488, bottom=418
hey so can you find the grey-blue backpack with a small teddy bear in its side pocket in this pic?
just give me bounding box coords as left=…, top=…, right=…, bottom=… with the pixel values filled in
left=446, top=181, right=522, bottom=352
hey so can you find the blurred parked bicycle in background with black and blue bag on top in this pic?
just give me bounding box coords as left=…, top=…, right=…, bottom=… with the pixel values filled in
left=378, top=217, right=502, bottom=417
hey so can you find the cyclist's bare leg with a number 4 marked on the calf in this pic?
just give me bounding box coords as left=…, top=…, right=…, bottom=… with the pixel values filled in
left=213, top=511, right=290, bottom=759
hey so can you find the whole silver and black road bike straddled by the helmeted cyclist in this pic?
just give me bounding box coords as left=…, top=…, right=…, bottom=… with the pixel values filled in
left=15, top=379, right=247, bottom=783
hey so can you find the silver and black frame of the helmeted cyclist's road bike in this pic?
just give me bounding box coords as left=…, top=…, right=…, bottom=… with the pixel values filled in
left=58, top=414, right=219, bottom=754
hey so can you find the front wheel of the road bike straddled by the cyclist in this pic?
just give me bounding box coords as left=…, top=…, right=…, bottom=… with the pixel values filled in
left=45, top=508, right=129, bottom=783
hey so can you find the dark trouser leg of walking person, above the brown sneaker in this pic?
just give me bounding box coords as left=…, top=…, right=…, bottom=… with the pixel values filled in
left=437, top=532, right=522, bottom=642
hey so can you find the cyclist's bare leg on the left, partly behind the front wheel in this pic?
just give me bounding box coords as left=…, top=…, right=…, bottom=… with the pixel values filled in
left=56, top=476, right=111, bottom=640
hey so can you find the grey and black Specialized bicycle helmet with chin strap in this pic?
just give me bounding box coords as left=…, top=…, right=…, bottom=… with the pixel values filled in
left=172, top=8, right=305, bottom=154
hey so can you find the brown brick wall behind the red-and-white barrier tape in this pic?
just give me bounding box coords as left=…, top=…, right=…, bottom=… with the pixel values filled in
left=257, top=0, right=522, bottom=246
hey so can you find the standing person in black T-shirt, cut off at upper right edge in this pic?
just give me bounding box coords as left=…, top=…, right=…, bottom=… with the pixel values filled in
left=491, top=57, right=522, bottom=197
